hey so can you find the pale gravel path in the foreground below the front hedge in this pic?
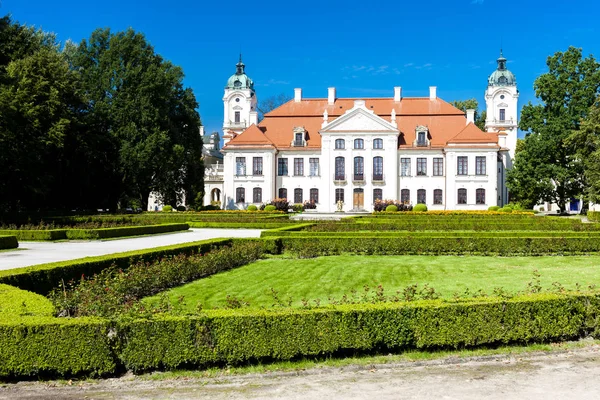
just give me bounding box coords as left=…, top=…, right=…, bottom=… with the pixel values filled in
left=0, top=345, right=600, bottom=400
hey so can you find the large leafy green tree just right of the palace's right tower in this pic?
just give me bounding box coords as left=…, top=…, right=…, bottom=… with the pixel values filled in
left=507, top=47, right=600, bottom=212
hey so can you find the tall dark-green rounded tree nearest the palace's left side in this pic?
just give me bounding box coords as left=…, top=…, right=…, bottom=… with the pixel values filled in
left=73, top=29, right=203, bottom=209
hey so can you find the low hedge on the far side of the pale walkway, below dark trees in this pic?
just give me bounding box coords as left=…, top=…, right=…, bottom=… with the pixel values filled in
left=0, top=224, right=189, bottom=241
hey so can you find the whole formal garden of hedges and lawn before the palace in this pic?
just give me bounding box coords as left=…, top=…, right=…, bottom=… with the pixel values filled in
left=0, top=211, right=600, bottom=379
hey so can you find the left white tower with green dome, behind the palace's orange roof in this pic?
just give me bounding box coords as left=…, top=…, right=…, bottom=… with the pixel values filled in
left=223, top=54, right=258, bottom=144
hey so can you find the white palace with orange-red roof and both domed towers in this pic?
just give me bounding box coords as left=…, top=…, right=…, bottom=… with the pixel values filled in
left=205, top=55, right=519, bottom=212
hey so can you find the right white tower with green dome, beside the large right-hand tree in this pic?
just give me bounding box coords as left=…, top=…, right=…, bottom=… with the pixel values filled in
left=485, top=50, right=519, bottom=159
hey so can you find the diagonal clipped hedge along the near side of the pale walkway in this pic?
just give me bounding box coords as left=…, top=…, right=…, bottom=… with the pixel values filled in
left=0, top=239, right=232, bottom=295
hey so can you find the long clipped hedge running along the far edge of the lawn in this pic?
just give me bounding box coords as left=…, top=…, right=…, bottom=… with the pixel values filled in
left=276, top=235, right=600, bottom=257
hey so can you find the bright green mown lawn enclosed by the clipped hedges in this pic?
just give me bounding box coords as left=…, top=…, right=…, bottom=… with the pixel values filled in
left=145, top=255, right=600, bottom=311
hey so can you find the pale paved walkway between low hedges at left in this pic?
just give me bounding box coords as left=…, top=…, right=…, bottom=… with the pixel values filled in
left=0, top=229, right=261, bottom=270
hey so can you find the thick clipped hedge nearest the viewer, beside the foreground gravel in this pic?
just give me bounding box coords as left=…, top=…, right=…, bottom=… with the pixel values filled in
left=0, top=294, right=600, bottom=378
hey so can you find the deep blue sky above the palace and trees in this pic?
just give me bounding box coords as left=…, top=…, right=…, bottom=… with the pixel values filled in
left=0, top=0, right=600, bottom=136
